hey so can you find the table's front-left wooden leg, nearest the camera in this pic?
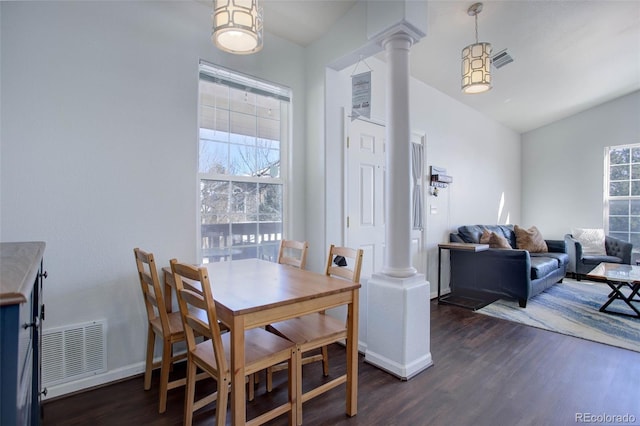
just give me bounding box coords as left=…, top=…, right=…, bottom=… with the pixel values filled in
left=229, top=316, right=247, bottom=425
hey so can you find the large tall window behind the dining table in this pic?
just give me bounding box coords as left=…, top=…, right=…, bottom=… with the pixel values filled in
left=198, top=62, right=290, bottom=263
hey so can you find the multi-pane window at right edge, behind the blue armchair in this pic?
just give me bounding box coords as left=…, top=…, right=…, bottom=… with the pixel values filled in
left=605, top=144, right=640, bottom=251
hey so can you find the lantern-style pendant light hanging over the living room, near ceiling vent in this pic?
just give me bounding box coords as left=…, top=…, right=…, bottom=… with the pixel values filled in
left=462, top=3, right=491, bottom=93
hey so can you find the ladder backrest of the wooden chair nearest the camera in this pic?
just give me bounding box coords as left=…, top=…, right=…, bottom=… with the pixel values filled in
left=170, top=259, right=227, bottom=372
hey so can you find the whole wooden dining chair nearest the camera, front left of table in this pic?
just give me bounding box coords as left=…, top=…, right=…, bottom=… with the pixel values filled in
left=170, top=259, right=298, bottom=426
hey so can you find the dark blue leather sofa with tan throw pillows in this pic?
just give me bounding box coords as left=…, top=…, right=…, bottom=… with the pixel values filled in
left=449, top=225, right=569, bottom=308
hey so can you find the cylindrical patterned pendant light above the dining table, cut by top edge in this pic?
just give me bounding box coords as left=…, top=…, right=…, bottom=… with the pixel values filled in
left=211, top=0, right=262, bottom=55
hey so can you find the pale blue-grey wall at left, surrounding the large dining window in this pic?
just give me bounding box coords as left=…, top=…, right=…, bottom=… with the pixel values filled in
left=0, top=1, right=306, bottom=396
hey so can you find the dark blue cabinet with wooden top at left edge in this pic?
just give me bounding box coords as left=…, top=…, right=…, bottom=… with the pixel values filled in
left=0, top=242, right=46, bottom=426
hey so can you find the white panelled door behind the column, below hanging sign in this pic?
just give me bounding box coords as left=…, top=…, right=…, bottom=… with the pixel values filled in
left=345, top=119, right=426, bottom=277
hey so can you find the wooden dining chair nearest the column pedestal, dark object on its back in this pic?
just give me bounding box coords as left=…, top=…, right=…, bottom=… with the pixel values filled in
left=267, top=244, right=363, bottom=424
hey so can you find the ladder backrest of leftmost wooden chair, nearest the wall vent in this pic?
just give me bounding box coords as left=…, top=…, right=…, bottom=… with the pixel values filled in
left=133, top=247, right=169, bottom=333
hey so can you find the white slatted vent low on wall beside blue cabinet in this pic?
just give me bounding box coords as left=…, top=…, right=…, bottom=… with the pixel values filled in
left=42, top=320, right=107, bottom=386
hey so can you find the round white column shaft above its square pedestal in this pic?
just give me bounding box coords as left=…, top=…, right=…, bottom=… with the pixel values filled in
left=381, top=33, right=416, bottom=278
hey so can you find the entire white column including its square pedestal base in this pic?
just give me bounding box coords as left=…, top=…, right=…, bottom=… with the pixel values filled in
left=365, top=28, right=433, bottom=379
